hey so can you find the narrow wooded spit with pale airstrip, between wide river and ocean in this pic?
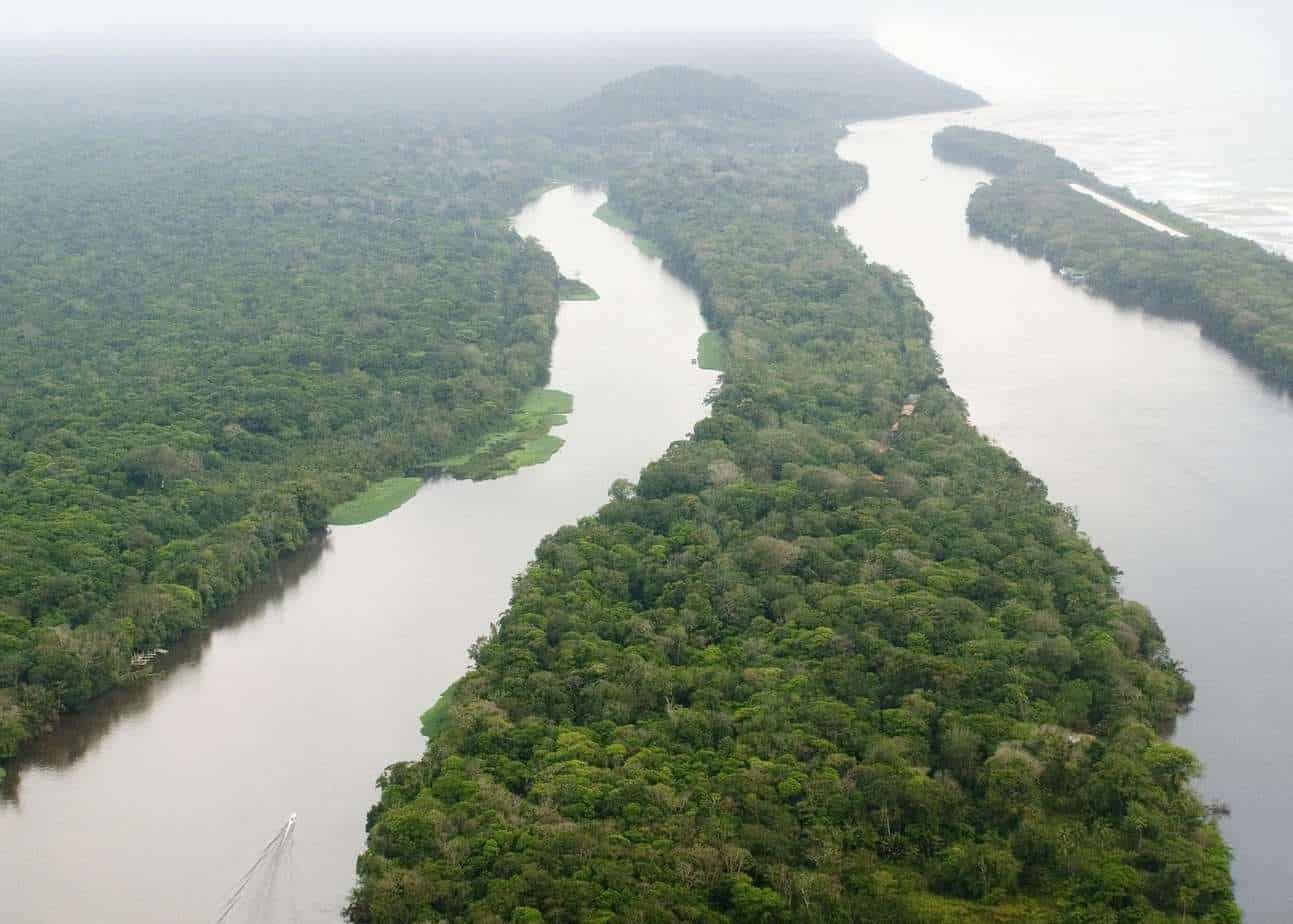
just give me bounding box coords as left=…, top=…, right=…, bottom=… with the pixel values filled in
left=934, top=127, right=1293, bottom=384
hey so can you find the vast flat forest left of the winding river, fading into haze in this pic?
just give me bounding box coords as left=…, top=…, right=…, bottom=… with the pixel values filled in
left=0, top=35, right=981, bottom=773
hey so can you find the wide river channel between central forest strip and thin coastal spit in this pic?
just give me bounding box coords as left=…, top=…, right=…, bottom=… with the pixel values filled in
left=837, top=115, right=1293, bottom=924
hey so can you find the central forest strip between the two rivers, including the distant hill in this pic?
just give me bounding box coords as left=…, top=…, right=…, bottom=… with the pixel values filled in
left=349, top=70, right=1239, bottom=924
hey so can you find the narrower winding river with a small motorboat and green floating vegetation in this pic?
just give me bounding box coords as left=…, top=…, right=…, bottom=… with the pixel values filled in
left=0, top=186, right=716, bottom=924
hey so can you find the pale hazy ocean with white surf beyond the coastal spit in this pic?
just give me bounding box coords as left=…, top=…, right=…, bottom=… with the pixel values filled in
left=877, top=3, right=1293, bottom=256
